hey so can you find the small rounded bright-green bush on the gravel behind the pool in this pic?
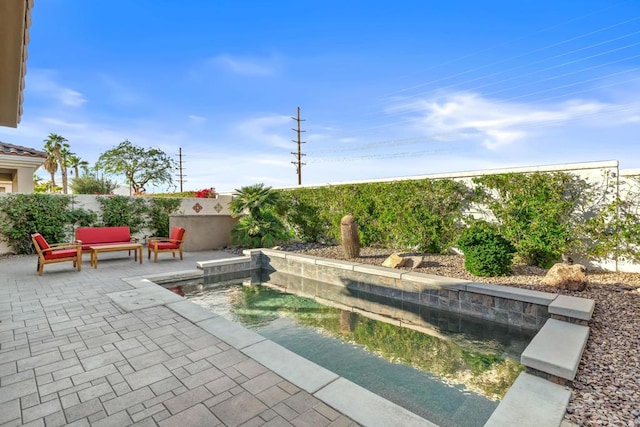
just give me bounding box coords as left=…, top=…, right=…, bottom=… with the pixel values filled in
left=458, top=222, right=515, bottom=276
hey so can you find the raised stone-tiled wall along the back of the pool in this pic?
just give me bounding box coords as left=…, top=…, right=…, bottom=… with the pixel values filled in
left=200, top=249, right=557, bottom=330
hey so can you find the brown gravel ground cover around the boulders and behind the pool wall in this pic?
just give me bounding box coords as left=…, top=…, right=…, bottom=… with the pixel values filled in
left=281, top=244, right=640, bottom=427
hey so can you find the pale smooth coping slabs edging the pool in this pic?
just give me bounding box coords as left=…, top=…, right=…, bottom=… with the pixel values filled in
left=132, top=249, right=594, bottom=426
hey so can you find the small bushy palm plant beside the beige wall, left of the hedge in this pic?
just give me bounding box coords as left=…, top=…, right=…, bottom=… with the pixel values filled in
left=229, top=184, right=289, bottom=248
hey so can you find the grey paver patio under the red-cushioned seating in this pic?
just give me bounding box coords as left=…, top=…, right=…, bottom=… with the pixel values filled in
left=0, top=251, right=355, bottom=427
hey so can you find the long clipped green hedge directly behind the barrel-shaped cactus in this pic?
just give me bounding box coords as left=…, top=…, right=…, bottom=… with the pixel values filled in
left=279, top=179, right=472, bottom=252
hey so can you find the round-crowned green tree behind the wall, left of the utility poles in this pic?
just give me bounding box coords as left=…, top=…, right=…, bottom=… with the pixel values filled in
left=96, top=140, right=176, bottom=193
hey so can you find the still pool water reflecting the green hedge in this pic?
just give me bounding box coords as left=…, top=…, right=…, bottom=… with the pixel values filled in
left=165, top=276, right=531, bottom=426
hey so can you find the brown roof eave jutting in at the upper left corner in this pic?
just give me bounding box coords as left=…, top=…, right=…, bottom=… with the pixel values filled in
left=0, top=0, right=34, bottom=127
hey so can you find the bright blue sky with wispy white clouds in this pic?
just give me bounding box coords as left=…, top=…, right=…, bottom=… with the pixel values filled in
left=0, top=0, right=640, bottom=191
